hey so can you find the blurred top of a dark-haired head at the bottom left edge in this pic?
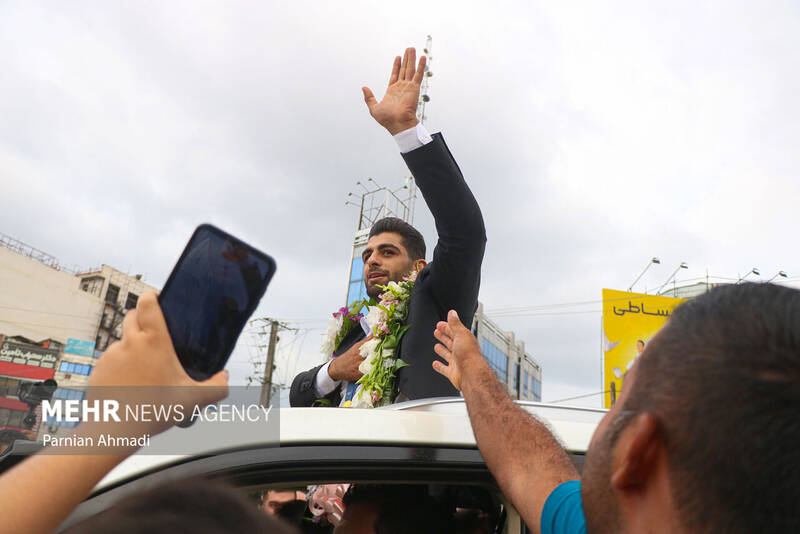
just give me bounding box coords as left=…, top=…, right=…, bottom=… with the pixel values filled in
left=65, top=480, right=299, bottom=534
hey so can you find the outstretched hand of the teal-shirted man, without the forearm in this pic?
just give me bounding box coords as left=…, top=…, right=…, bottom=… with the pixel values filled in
left=433, top=310, right=483, bottom=390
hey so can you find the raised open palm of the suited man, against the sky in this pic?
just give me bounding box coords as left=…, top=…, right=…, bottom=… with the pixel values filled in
left=361, top=48, right=426, bottom=135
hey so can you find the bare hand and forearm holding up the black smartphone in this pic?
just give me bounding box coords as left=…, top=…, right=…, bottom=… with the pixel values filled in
left=0, top=293, right=228, bottom=534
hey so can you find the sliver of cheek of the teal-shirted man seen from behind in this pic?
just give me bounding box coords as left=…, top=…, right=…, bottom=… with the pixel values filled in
left=581, top=358, right=641, bottom=534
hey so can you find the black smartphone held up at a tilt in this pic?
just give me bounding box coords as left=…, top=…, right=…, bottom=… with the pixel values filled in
left=158, top=224, right=275, bottom=380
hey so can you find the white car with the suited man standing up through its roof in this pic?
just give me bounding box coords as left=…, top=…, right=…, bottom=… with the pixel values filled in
left=3, top=398, right=606, bottom=534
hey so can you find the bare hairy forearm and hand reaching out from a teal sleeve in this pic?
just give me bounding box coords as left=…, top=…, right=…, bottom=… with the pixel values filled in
left=433, top=311, right=579, bottom=532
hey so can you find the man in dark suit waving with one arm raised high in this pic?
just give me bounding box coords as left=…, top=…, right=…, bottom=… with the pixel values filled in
left=289, top=48, right=486, bottom=406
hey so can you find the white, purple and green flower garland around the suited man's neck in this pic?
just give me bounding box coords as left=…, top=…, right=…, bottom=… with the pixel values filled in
left=322, top=270, right=417, bottom=408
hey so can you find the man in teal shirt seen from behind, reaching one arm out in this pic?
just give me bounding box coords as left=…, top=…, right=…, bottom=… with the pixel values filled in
left=433, top=283, right=800, bottom=534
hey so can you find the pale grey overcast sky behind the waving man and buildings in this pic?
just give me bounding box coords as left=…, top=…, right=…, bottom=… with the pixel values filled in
left=0, top=1, right=800, bottom=406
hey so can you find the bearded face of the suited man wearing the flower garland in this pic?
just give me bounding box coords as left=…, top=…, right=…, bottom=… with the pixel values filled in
left=361, top=232, right=414, bottom=300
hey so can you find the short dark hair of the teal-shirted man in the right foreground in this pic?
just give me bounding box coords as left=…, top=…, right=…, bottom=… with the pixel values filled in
left=622, top=283, right=800, bottom=533
